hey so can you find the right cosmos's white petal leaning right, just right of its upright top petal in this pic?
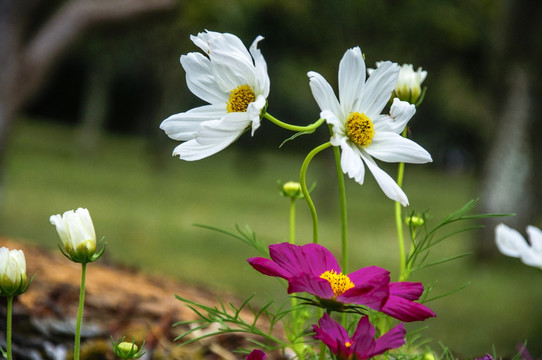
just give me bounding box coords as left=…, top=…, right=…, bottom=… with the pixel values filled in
left=356, top=61, right=399, bottom=119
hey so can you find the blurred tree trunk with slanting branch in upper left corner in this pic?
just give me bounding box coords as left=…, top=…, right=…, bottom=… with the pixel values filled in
left=0, top=0, right=176, bottom=180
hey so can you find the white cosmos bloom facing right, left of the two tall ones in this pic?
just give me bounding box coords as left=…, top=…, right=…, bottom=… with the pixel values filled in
left=160, top=31, right=269, bottom=160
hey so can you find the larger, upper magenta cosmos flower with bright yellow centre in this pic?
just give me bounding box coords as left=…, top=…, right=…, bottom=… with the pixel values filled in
left=247, top=243, right=436, bottom=321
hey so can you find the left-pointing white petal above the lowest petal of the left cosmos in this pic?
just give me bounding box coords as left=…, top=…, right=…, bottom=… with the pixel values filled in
left=160, top=103, right=227, bottom=141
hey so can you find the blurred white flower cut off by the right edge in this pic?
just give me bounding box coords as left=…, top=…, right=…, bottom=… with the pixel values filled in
left=495, top=224, right=542, bottom=269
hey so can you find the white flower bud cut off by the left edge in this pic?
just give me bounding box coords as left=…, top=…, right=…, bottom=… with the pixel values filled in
left=0, top=247, right=27, bottom=296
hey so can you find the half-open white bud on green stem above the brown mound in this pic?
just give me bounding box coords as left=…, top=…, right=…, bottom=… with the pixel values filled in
left=49, top=208, right=96, bottom=262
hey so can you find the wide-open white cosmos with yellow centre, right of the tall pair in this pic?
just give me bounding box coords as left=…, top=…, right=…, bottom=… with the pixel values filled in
left=308, top=47, right=432, bottom=206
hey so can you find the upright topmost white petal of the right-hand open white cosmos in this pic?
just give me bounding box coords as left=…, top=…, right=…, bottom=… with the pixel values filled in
left=339, top=47, right=365, bottom=111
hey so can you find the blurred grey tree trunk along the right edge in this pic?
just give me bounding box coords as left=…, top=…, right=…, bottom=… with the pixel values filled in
left=476, top=0, right=542, bottom=257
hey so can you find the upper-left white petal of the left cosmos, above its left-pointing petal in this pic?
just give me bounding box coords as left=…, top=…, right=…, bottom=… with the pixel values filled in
left=181, top=53, right=227, bottom=104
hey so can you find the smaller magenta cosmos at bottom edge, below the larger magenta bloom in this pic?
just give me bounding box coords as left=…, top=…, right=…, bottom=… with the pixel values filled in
left=312, top=314, right=406, bottom=360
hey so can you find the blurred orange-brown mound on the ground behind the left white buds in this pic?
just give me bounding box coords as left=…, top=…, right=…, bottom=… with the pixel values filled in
left=0, top=238, right=280, bottom=360
